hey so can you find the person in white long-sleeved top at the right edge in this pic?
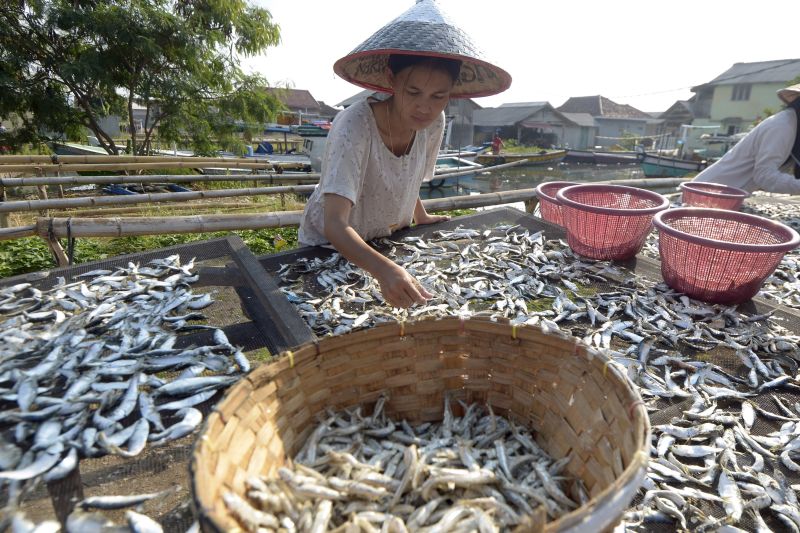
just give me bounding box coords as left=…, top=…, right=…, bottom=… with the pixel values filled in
left=693, top=84, right=800, bottom=194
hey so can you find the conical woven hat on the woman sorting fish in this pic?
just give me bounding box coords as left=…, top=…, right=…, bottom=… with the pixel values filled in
left=333, top=0, right=511, bottom=98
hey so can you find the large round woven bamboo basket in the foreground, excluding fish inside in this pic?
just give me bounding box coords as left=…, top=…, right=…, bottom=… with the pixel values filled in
left=190, top=318, right=650, bottom=533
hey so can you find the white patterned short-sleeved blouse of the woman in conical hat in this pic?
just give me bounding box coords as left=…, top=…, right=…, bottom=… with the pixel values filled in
left=298, top=99, right=444, bottom=246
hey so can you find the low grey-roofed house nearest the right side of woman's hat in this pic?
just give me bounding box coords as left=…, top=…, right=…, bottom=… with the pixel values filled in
left=474, top=102, right=596, bottom=148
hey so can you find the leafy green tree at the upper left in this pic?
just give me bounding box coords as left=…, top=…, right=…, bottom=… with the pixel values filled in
left=0, top=0, right=282, bottom=153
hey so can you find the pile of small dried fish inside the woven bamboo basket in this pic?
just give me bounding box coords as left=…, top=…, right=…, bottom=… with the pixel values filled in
left=223, top=397, right=588, bottom=532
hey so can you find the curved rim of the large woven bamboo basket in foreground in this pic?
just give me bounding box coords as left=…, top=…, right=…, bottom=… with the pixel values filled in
left=189, top=317, right=651, bottom=532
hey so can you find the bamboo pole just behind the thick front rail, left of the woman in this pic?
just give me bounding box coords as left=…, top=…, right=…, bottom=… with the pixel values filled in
left=0, top=185, right=315, bottom=213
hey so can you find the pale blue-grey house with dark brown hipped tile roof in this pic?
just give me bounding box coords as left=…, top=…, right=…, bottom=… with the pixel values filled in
left=556, top=95, right=653, bottom=147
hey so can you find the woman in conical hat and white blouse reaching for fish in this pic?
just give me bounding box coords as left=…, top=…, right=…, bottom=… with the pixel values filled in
left=299, top=0, right=511, bottom=308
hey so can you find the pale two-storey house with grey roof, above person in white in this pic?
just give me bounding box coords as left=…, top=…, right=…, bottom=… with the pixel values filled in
left=687, top=59, right=800, bottom=154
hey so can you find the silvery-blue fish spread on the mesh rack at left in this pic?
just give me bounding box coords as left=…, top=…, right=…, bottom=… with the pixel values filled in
left=0, top=255, right=249, bottom=502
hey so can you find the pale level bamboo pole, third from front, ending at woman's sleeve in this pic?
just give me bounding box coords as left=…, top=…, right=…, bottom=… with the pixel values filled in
left=0, top=173, right=320, bottom=187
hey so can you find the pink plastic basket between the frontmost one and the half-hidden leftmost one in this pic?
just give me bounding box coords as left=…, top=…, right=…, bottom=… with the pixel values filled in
left=556, top=183, right=669, bottom=260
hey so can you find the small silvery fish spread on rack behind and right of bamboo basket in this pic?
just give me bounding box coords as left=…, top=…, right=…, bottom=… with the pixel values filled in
left=282, top=227, right=800, bottom=532
